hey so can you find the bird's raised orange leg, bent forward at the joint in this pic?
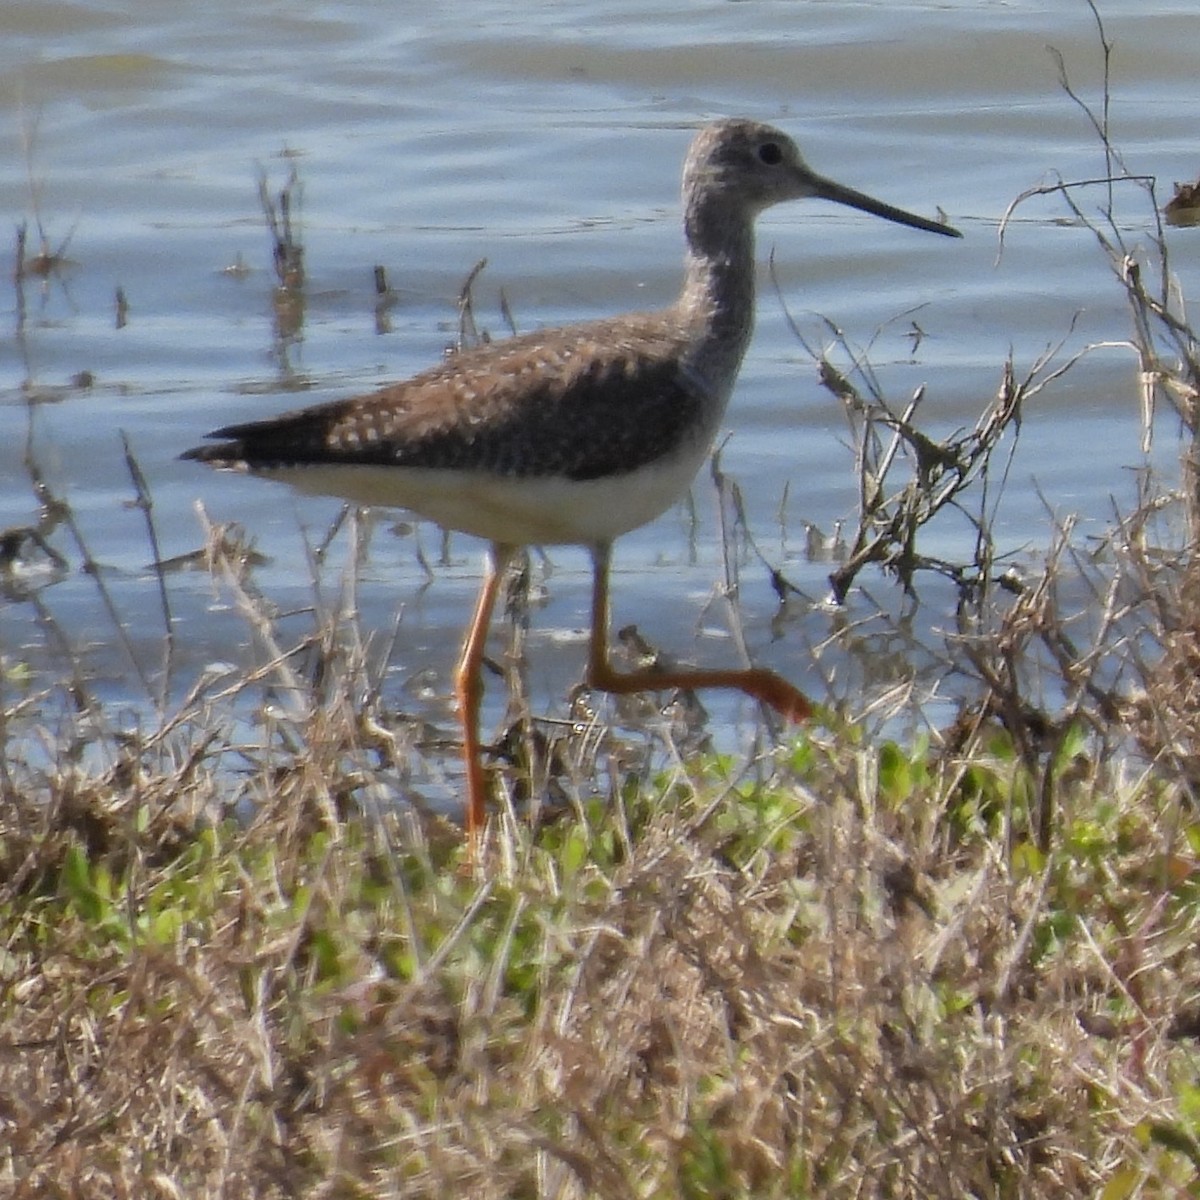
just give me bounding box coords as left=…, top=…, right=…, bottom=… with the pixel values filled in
left=588, top=546, right=812, bottom=721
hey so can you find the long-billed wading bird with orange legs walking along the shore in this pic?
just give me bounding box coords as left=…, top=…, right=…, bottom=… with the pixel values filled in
left=184, top=120, right=960, bottom=839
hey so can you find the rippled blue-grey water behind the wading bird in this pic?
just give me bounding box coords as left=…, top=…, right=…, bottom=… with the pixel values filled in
left=0, top=0, right=1200, bottom=763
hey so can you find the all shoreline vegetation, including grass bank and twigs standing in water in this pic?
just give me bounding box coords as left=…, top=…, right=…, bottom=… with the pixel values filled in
left=0, top=21, right=1200, bottom=1200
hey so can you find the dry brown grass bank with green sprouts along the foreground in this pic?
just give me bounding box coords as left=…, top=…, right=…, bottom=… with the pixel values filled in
left=0, top=595, right=1200, bottom=1200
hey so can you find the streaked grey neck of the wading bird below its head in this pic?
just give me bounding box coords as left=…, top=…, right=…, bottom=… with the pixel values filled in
left=679, top=197, right=755, bottom=396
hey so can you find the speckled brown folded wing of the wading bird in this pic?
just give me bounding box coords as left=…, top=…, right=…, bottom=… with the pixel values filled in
left=184, top=314, right=704, bottom=480
